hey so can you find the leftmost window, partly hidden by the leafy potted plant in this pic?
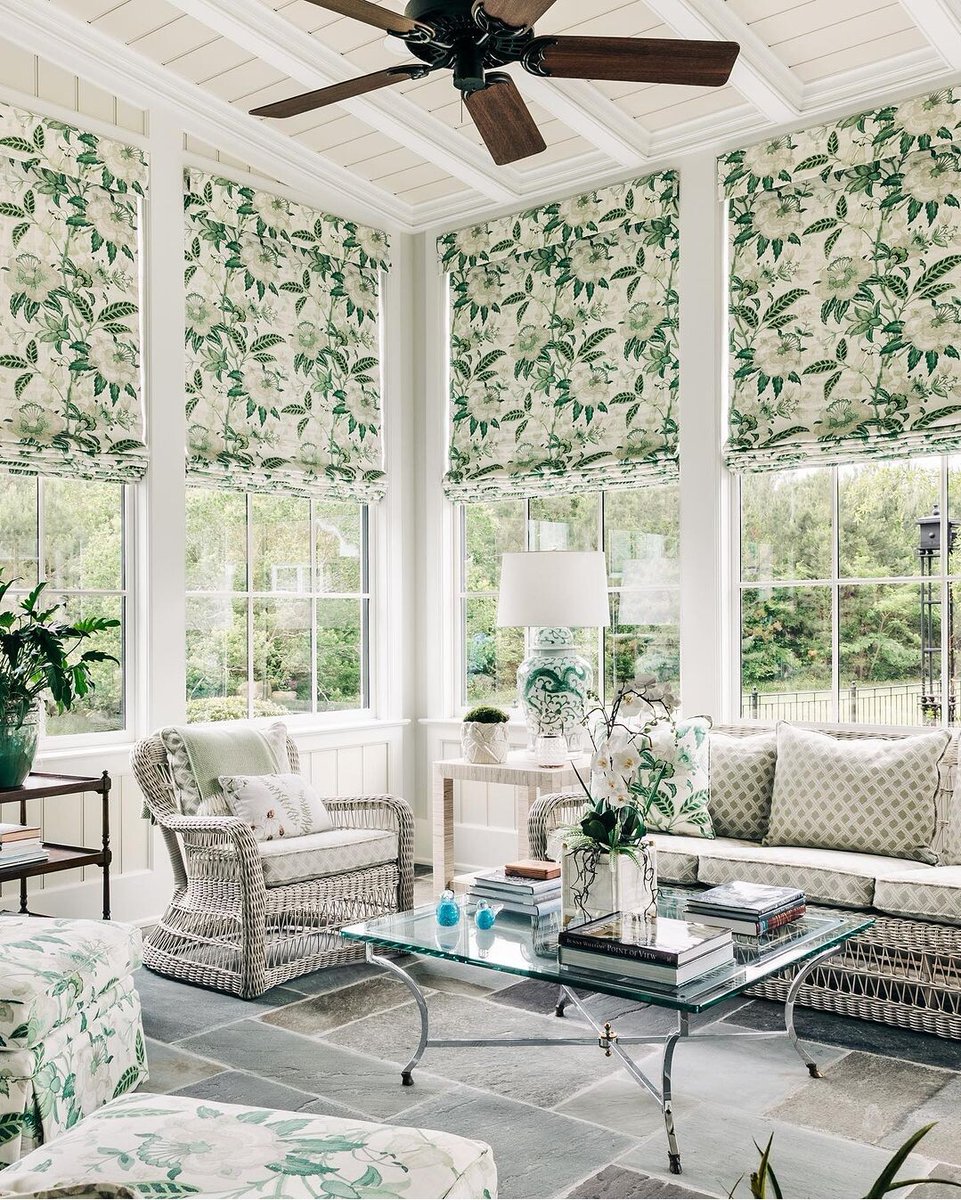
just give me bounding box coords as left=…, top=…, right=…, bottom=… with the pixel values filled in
left=0, top=473, right=128, bottom=737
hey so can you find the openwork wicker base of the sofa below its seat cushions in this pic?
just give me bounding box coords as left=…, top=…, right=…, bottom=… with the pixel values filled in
left=747, top=917, right=961, bottom=1039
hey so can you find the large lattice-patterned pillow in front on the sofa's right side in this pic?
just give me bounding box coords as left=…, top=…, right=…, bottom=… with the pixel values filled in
left=764, top=722, right=950, bottom=863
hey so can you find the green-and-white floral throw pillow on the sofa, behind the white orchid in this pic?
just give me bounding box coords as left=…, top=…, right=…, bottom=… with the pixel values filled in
left=638, top=716, right=714, bottom=838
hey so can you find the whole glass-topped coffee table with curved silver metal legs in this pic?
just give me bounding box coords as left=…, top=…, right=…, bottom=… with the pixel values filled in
left=341, top=888, right=873, bottom=1175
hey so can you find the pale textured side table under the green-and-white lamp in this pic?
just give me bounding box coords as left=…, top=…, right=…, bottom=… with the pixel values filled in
left=433, top=752, right=580, bottom=889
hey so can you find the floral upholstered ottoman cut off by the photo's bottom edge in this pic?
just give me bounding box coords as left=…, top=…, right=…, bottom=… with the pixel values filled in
left=0, top=1094, right=497, bottom=1200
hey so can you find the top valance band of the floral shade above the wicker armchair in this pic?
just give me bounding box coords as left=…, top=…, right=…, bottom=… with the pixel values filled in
left=187, top=169, right=390, bottom=271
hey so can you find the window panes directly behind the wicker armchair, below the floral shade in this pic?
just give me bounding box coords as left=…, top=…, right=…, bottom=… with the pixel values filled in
left=187, top=487, right=370, bottom=721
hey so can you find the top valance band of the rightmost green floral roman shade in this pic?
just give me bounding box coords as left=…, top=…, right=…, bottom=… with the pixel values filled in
left=717, top=89, right=961, bottom=203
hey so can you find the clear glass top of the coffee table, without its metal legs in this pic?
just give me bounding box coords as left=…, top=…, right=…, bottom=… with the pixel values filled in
left=341, top=888, right=873, bottom=1013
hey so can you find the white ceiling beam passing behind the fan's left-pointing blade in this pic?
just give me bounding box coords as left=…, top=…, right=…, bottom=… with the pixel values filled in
left=173, top=0, right=523, bottom=203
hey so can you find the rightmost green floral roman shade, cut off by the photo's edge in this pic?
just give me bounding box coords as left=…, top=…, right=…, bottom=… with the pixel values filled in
left=719, top=90, right=961, bottom=470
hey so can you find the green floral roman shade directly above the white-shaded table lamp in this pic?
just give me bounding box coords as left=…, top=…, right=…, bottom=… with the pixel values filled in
left=438, top=172, right=678, bottom=500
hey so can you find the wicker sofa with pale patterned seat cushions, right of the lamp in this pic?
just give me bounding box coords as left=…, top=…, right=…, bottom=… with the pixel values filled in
left=529, top=725, right=961, bottom=1039
